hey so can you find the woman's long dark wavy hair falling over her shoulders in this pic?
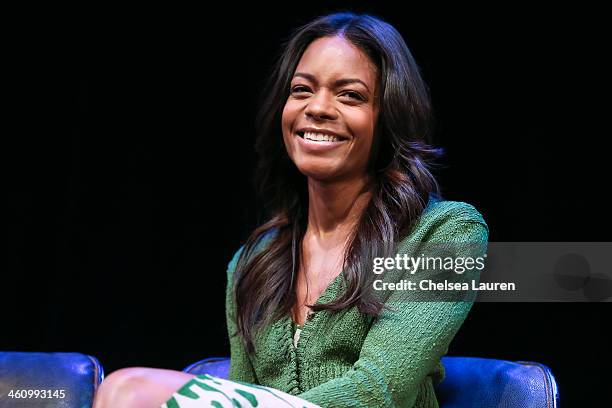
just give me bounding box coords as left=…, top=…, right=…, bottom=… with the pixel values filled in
left=232, top=12, right=442, bottom=353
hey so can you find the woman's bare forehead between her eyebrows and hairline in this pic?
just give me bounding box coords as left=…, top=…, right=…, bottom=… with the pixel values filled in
left=296, top=36, right=377, bottom=89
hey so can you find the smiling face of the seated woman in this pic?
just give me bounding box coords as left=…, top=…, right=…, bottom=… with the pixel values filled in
left=282, top=36, right=378, bottom=181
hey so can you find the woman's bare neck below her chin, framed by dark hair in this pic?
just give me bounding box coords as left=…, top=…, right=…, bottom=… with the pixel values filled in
left=307, top=178, right=372, bottom=239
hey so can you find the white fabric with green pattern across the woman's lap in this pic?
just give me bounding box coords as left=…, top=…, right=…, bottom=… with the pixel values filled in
left=162, top=374, right=320, bottom=408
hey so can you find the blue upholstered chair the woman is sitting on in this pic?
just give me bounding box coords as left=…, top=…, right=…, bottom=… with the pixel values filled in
left=183, top=357, right=559, bottom=408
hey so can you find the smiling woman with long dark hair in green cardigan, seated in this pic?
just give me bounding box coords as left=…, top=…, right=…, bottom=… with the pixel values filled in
left=94, top=13, right=488, bottom=408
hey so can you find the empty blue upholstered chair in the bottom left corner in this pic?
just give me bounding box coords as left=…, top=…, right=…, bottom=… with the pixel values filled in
left=0, top=352, right=104, bottom=408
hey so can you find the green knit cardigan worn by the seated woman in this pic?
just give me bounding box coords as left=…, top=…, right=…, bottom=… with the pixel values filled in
left=226, top=200, right=488, bottom=408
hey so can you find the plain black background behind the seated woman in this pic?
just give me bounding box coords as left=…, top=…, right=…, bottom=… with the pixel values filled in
left=5, top=3, right=610, bottom=406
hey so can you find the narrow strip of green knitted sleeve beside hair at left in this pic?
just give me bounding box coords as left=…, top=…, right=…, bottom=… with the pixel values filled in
left=225, top=247, right=258, bottom=384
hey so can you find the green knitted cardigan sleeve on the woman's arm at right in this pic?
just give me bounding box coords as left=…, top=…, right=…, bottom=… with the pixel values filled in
left=298, top=214, right=488, bottom=408
